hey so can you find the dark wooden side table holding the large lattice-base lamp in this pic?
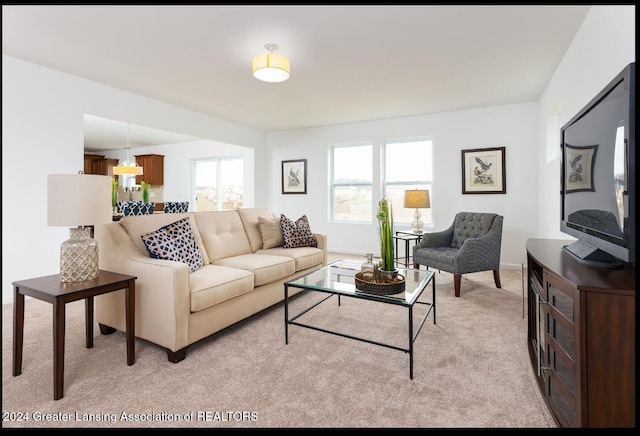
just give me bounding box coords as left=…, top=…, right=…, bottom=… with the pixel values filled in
left=13, top=270, right=137, bottom=400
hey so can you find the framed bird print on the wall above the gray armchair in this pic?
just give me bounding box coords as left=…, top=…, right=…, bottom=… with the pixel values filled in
left=462, top=147, right=507, bottom=194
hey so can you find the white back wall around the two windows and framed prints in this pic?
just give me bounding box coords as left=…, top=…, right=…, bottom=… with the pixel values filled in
left=268, top=103, right=538, bottom=268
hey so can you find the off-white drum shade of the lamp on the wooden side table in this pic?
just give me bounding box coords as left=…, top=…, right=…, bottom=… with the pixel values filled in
left=47, top=174, right=112, bottom=227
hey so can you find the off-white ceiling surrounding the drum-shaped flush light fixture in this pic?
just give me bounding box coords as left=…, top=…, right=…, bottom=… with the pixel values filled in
left=2, top=5, right=590, bottom=150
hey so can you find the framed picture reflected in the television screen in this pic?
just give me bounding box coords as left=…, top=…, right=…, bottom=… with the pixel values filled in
left=564, top=144, right=598, bottom=194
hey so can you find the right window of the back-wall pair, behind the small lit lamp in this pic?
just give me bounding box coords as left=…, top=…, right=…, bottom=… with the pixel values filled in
left=382, top=139, right=433, bottom=226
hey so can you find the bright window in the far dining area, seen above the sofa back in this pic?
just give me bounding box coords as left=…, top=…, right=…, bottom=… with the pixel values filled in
left=192, top=158, right=243, bottom=212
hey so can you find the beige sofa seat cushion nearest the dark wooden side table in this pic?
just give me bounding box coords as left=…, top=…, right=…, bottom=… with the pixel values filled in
left=189, top=265, right=254, bottom=312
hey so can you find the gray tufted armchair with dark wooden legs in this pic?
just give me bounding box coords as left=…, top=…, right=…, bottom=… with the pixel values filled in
left=413, top=212, right=503, bottom=297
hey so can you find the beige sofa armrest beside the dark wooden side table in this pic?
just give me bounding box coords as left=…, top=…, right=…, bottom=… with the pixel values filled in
left=95, top=223, right=191, bottom=351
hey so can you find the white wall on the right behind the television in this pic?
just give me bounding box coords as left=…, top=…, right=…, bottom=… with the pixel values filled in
left=537, top=6, right=636, bottom=240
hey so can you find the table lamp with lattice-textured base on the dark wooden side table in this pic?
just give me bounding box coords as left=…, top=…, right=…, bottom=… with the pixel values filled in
left=47, top=172, right=112, bottom=283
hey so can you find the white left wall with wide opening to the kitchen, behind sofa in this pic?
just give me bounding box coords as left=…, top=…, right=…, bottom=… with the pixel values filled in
left=2, top=55, right=268, bottom=303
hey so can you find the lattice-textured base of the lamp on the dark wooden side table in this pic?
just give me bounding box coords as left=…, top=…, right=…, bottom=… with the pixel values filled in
left=60, top=227, right=98, bottom=283
